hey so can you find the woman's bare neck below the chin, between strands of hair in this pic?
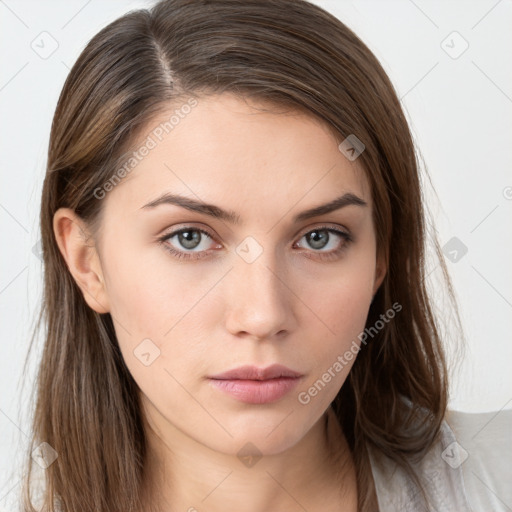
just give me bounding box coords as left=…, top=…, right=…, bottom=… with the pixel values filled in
left=140, top=408, right=357, bottom=512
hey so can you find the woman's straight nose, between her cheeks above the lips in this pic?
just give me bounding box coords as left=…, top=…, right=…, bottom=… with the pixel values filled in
left=225, top=251, right=296, bottom=340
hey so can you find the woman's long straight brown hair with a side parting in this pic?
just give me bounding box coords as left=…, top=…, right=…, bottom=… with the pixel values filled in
left=23, top=0, right=460, bottom=512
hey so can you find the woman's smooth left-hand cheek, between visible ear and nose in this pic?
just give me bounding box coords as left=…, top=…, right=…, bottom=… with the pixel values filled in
left=102, top=240, right=225, bottom=388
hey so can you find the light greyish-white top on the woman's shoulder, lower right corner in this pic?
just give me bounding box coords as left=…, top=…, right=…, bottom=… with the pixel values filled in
left=370, top=410, right=512, bottom=512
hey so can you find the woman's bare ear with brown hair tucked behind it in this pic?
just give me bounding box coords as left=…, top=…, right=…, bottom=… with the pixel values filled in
left=53, top=208, right=110, bottom=313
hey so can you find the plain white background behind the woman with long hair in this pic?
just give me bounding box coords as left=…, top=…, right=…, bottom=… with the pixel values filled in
left=0, top=0, right=512, bottom=510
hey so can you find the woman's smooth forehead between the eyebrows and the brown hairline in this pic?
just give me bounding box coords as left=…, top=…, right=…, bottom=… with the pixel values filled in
left=104, top=94, right=371, bottom=216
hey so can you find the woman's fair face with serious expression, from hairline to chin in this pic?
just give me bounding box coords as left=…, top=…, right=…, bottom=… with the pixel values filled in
left=62, top=95, right=383, bottom=454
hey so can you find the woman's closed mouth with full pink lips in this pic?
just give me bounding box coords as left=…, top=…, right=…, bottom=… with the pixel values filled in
left=208, top=364, right=303, bottom=404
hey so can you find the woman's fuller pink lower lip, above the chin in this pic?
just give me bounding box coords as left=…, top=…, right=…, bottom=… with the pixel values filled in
left=210, top=377, right=300, bottom=404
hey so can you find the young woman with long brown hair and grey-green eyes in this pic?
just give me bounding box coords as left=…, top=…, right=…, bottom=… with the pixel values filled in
left=19, top=0, right=480, bottom=512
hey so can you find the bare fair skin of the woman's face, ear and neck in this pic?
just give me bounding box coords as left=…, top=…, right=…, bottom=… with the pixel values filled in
left=54, top=95, right=385, bottom=512
